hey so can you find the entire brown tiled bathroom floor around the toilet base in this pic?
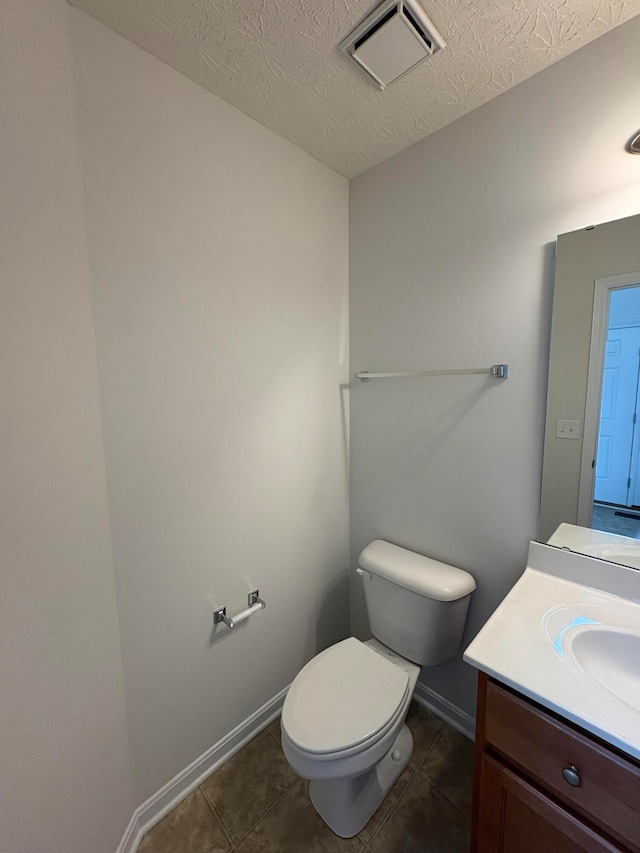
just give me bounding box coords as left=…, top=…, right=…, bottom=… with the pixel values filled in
left=139, top=702, right=473, bottom=853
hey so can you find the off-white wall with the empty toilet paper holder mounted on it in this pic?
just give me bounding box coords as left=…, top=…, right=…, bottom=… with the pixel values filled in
left=72, top=11, right=349, bottom=801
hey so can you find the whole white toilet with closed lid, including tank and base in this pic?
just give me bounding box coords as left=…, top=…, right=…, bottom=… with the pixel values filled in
left=282, top=539, right=476, bottom=838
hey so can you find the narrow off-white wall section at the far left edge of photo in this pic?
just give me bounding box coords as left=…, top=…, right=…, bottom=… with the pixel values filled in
left=0, top=0, right=135, bottom=853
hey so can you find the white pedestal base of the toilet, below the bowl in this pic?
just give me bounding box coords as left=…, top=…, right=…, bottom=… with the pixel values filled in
left=309, top=724, right=413, bottom=838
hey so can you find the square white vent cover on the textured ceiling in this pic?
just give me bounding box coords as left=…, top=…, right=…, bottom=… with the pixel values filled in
left=340, top=0, right=446, bottom=89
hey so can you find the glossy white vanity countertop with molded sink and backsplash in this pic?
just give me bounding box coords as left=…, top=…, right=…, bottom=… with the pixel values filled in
left=464, top=542, right=640, bottom=759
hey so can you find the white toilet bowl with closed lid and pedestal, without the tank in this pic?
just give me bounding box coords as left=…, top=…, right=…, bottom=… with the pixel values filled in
left=281, top=637, right=420, bottom=838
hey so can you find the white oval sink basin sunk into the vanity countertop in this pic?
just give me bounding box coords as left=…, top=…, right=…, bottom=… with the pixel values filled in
left=565, top=625, right=640, bottom=710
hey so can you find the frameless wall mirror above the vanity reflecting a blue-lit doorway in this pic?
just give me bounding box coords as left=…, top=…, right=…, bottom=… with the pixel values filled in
left=538, top=215, right=640, bottom=562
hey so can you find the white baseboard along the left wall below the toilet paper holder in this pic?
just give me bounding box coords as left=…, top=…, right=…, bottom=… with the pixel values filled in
left=116, top=687, right=289, bottom=853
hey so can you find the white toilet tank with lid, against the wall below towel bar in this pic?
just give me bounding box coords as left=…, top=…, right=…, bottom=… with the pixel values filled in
left=359, top=539, right=476, bottom=666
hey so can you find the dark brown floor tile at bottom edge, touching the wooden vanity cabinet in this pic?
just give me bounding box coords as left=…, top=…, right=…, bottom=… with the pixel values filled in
left=370, top=773, right=471, bottom=853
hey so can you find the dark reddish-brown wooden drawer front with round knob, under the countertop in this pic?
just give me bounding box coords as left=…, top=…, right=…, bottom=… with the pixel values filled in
left=484, top=681, right=640, bottom=853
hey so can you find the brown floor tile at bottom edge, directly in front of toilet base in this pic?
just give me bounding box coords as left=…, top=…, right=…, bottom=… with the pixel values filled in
left=237, top=780, right=365, bottom=853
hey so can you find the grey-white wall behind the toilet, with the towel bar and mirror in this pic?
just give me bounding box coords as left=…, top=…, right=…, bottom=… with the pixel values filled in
left=350, top=18, right=640, bottom=712
